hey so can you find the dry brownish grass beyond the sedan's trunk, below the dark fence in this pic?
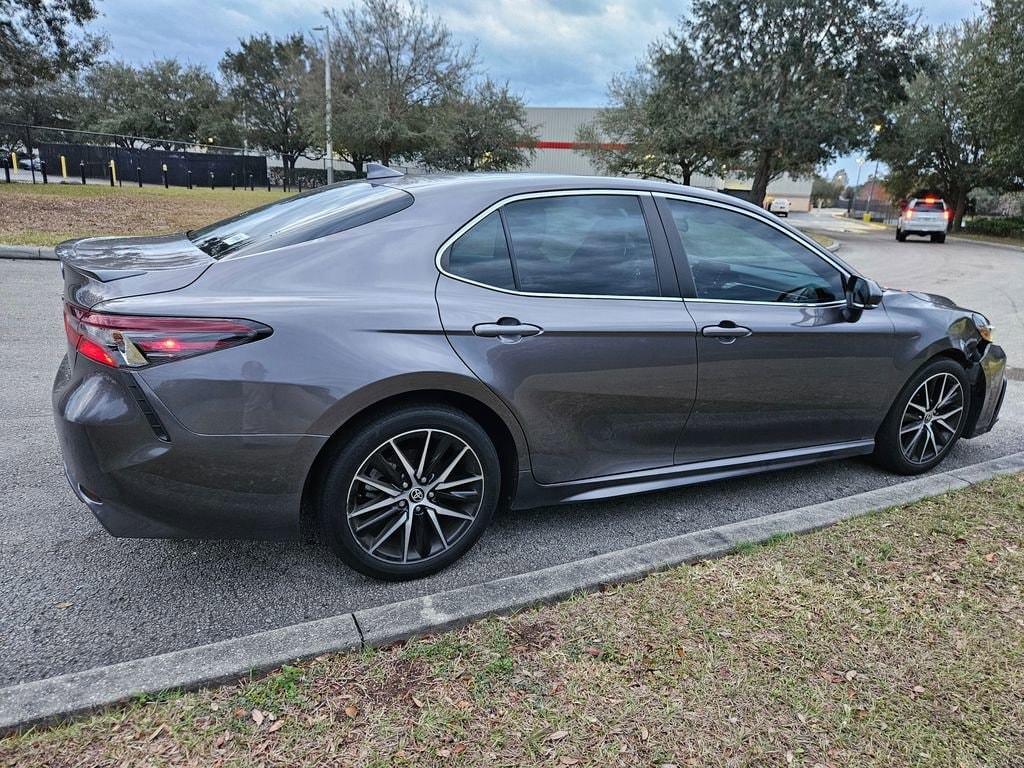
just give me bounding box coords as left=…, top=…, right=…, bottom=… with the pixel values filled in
left=0, top=183, right=292, bottom=246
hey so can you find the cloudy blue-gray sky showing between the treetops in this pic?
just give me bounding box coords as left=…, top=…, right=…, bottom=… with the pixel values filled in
left=97, top=0, right=978, bottom=179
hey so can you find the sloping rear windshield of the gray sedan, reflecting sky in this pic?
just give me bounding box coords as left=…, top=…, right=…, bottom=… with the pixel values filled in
left=188, top=180, right=413, bottom=259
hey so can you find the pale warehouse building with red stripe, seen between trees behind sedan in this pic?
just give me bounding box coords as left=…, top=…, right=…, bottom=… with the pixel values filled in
left=522, top=106, right=812, bottom=211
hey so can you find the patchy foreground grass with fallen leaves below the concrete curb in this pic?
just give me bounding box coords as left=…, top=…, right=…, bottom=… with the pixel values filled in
left=0, top=475, right=1024, bottom=768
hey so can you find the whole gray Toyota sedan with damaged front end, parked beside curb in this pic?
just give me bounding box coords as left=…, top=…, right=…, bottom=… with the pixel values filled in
left=53, top=166, right=1006, bottom=579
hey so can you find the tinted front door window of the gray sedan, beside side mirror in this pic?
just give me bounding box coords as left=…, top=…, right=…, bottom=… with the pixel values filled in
left=668, top=200, right=844, bottom=303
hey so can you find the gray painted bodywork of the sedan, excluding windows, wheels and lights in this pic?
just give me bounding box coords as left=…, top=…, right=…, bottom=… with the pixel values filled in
left=54, top=174, right=1005, bottom=538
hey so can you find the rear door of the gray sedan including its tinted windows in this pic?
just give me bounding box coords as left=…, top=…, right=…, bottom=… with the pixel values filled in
left=436, top=190, right=696, bottom=483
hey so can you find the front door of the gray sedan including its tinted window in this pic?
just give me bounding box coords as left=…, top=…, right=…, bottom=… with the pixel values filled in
left=658, top=197, right=894, bottom=463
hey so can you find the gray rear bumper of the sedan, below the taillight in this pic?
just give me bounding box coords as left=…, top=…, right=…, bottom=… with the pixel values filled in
left=53, top=357, right=326, bottom=540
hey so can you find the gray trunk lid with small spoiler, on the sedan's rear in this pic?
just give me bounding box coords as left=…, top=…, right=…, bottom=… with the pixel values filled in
left=55, top=233, right=214, bottom=307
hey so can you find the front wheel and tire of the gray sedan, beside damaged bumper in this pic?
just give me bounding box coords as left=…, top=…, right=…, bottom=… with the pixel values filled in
left=874, top=358, right=971, bottom=475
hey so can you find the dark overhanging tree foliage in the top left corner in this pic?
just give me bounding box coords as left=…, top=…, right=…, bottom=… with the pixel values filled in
left=0, top=0, right=104, bottom=89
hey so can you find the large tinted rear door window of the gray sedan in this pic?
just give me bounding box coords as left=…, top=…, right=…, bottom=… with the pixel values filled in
left=503, top=195, right=659, bottom=296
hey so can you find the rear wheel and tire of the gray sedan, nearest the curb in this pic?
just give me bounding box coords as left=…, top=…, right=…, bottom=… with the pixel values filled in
left=319, top=406, right=502, bottom=581
